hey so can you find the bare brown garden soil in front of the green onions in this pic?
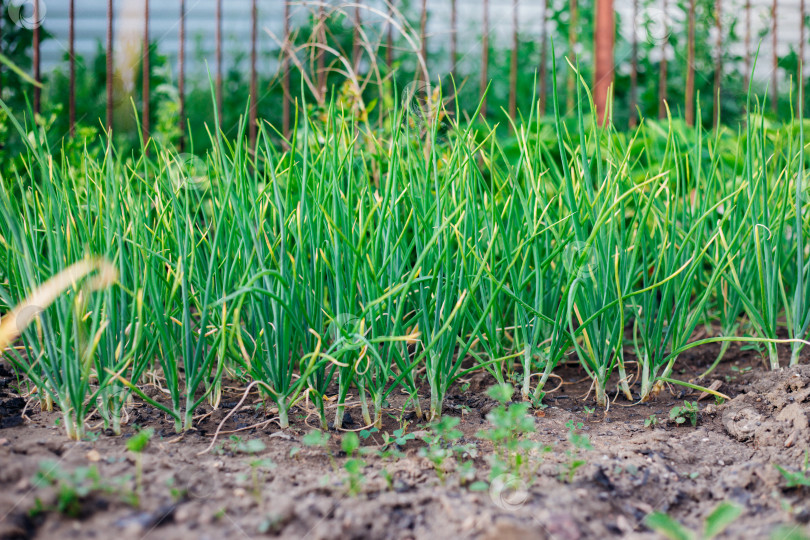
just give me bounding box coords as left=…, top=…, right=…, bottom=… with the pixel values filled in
left=0, top=347, right=810, bottom=540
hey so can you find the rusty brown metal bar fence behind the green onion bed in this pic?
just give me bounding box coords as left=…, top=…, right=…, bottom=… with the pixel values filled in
left=0, top=0, right=806, bottom=143
